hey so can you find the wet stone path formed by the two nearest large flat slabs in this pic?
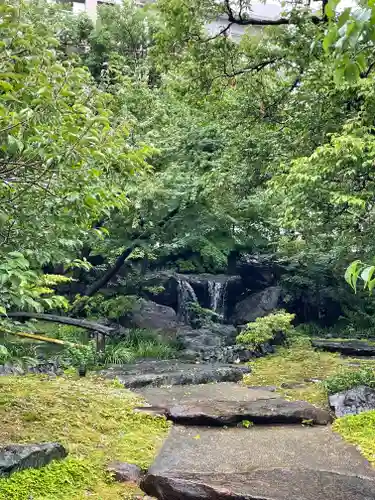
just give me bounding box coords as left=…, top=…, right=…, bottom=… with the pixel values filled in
left=137, top=383, right=375, bottom=500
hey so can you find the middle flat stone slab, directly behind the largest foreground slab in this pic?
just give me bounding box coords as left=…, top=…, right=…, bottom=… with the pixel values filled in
left=139, top=383, right=332, bottom=426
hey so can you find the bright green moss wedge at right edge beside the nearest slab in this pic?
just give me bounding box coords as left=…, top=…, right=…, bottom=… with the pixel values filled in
left=333, top=410, right=375, bottom=465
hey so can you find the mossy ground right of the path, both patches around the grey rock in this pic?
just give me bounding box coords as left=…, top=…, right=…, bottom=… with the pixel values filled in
left=244, top=338, right=375, bottom=466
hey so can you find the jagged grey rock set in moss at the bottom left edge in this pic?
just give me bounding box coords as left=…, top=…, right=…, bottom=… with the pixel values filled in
left=0, top=443, right=68, bottom=477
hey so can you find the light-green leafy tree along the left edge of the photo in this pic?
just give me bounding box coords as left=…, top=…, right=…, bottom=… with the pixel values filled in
left=0, top=1, right=152, bottom=307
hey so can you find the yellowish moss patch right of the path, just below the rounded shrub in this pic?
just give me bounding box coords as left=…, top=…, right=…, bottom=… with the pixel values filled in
left=244, top=337, right=375, bottom=407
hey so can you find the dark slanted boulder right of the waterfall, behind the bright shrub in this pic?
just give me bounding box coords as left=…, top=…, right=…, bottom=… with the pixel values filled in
left=231, top=286, right=281, bottom=325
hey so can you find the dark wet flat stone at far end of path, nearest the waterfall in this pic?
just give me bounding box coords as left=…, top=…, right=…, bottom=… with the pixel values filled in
left=100, top=360, right=250, bottom=389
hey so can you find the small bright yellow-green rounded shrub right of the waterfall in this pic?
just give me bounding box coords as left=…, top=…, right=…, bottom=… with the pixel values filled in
left=237, top=310, right=295, bottom=348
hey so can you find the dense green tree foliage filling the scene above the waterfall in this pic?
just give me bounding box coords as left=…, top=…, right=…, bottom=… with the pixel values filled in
left=0, top=0, right=375, bottom=324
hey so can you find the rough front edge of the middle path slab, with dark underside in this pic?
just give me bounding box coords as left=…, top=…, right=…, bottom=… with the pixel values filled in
left=165, top=399, right=332, bottom=426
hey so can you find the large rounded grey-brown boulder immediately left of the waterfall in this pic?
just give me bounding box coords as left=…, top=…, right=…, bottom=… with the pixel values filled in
left=120, top=299, right=180, bottom=338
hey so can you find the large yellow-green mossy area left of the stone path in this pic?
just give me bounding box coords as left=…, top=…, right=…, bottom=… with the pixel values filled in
left=0, top=376, right=169, bottom=500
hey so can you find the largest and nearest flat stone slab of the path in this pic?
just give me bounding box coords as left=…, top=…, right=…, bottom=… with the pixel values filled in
left=141, top=426, right=375, bottom=500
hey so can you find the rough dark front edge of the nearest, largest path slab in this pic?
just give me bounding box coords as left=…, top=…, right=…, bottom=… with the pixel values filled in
left=141, top=468, right=375, bottom=500
